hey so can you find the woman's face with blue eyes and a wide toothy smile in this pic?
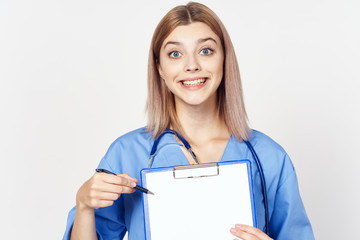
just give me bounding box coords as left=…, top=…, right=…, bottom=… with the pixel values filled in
left=158, top=22, right=224, bottom=107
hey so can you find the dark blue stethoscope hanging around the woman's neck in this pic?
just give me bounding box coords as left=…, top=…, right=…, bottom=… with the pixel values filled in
left=149, top=129, right=269, bottom=235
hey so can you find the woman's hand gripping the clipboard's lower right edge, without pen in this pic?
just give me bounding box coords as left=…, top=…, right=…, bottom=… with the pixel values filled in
left=230, top=224, right=273, bottom=240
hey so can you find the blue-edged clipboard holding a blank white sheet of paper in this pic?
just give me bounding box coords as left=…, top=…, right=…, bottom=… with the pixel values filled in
left=141, top=160, right=257, bottom=240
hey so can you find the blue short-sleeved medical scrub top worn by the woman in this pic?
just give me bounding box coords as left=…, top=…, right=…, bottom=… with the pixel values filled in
left=63, top=128, right=314, bottom=240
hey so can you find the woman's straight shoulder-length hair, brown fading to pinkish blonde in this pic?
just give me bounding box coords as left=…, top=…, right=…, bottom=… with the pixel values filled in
left=146, top=2, right=250, bottom=141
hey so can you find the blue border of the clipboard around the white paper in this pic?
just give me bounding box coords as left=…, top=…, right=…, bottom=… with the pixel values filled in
left=140, top=159, right=257, bottom=240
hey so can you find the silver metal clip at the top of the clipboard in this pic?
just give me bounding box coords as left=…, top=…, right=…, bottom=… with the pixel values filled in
left=173, top=163, right=219, bottom=179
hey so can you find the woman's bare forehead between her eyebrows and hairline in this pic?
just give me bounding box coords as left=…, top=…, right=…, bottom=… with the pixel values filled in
left=163, top=22, right=220, bottom=46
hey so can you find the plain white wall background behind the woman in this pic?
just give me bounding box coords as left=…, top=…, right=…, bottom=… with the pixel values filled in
left=0, top=0, right=360, bottom=240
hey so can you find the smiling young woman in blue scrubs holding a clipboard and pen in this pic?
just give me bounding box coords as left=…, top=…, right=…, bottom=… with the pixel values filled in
left=64, top=3, right=314, bottom=240
